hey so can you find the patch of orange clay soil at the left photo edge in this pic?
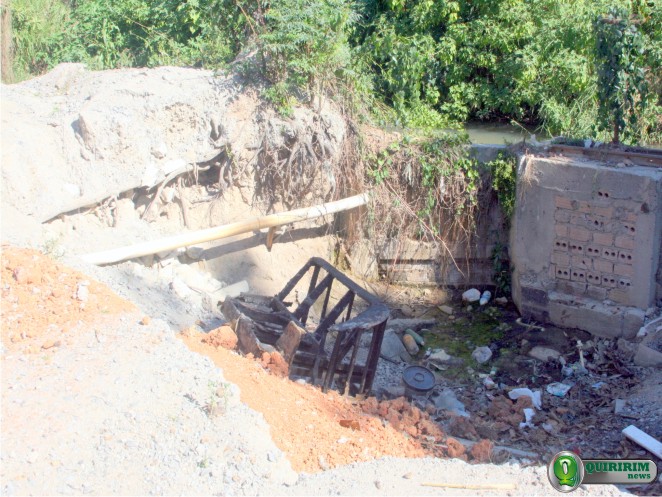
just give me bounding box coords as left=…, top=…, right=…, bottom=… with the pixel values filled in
left=0, top=246, right=136, bottom=353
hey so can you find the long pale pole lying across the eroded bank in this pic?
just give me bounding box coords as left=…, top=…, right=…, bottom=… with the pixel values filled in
left=82, top=193, right=368, bottom=264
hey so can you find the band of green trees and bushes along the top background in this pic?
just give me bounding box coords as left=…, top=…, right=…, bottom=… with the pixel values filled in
left=2, top=0, right=662, bottom=143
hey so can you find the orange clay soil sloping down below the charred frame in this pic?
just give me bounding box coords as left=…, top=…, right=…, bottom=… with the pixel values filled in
left=179, top=327, right=452, bottom=472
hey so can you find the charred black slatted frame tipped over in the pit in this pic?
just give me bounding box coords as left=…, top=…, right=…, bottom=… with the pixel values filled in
left=223, top=257, right=390, bottom=395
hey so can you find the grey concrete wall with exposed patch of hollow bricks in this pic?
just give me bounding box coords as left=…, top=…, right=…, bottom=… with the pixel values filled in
left=510, top=156, right=662, bottom=337
